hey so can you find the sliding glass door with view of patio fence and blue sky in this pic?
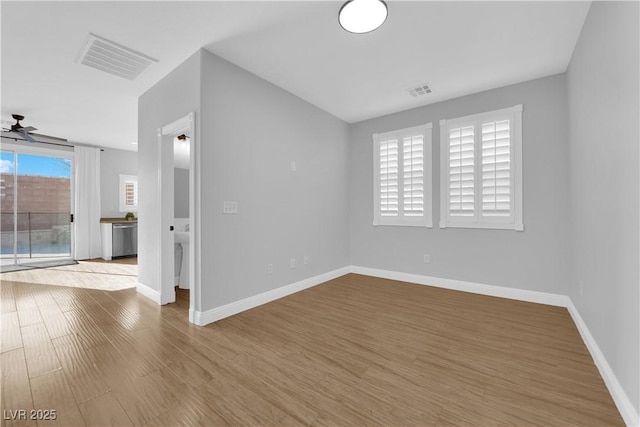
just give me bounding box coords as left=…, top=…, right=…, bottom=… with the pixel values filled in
left=0, top=144, right=72, bottom=265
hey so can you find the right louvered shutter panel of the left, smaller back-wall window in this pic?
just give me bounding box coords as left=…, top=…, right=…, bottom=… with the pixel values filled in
left=402, top=135, right=424, bottom=216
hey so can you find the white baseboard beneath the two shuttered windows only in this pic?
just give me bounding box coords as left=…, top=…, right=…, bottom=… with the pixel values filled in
left=350, top=265, right=569, bottom=307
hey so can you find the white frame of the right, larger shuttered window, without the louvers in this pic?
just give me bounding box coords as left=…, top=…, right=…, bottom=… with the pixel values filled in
left=440, top=104, right=524, bottom=231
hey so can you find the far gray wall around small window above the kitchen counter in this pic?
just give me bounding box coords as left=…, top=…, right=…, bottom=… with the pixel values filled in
left=100, top=148, right=138, bottom=218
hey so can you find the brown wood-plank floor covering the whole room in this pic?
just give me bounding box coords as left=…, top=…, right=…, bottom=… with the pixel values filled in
left=1, top=274, right=623, bottom=426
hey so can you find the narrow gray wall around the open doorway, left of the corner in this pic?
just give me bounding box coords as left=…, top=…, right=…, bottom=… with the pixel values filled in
left=138, top=52, right=200, bottom=292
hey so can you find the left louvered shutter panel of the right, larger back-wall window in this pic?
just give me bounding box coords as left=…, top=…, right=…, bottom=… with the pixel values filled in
left=449, top=126, right=475, bottom=216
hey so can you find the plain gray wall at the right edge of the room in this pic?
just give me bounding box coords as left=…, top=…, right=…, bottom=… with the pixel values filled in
left=567, top=2, right=640, bottom=412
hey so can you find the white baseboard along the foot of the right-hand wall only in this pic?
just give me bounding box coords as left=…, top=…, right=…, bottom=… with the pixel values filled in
left=567, top=299, right=640, bottom=426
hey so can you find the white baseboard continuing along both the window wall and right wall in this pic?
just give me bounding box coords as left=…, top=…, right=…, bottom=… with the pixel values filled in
left=349, top=266, right=640, bottom=426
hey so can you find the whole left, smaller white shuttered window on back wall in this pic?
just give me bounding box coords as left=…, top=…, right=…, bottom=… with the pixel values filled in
left=373, top=123, right=432, bottom=227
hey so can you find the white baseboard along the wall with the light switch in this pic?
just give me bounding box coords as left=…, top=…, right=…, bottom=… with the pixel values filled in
left=193, top=267, right=349, bottom=326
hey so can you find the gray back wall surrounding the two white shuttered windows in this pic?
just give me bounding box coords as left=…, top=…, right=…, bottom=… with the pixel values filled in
left=349, top=75, right=568, bottom=294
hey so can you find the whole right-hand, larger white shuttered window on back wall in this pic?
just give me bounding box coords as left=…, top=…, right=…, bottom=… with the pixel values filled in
left=440, top=105, right=524, bottom=231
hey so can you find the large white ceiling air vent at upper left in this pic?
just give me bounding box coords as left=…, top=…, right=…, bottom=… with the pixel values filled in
left=76, top=33, right=158, bottom=80
